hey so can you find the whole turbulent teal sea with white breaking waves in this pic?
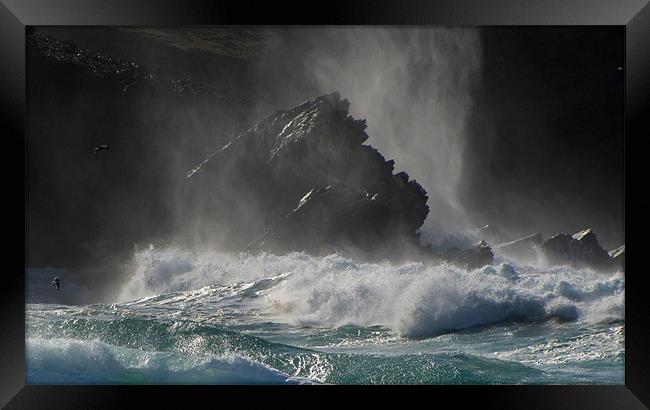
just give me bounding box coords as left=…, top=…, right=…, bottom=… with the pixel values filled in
left=26, top=247, right=625, bottom=384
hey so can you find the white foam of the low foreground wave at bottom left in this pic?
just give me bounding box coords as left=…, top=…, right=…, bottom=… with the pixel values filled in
left=26, top=338, right=304, bottom=384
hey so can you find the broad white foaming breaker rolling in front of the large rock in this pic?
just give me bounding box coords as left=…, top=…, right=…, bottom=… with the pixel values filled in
left=117, top=248, right=624, bottom=337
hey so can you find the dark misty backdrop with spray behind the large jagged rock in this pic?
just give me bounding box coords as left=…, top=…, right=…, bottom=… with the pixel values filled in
left=26, top=27, right=624, bottom=298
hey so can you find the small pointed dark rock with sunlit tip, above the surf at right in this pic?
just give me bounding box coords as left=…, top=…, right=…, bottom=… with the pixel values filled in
left=540, top=229, right=611, bottom=270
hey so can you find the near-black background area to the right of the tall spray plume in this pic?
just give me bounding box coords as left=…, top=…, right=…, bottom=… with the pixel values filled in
left=462, top=27, right=625, bottom=247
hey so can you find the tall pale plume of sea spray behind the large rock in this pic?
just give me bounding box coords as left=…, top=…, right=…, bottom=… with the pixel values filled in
left=292, top=28, right=481, bottom=234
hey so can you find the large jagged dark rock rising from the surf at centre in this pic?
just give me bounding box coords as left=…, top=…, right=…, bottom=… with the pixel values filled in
left=186, top=93, right=429, bottom=253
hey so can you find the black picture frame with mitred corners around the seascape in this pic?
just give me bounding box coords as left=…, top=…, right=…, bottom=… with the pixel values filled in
left=0, top=0, right=650, bottom=409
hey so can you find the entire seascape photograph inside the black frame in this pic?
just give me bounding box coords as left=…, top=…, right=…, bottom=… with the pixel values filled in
left=24, top=25, right=632, bottom=386
